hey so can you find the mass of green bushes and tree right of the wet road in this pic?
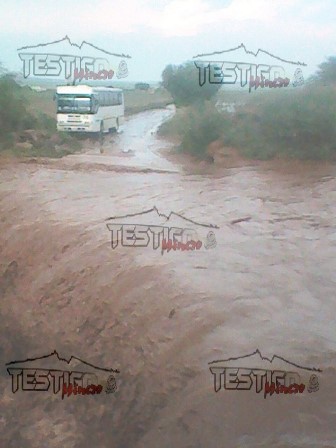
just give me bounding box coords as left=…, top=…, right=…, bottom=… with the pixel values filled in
left=159, top=57, right=336, bottom=160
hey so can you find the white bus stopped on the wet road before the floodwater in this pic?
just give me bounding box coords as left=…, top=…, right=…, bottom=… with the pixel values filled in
left=56, top=85, right=124, bottom=133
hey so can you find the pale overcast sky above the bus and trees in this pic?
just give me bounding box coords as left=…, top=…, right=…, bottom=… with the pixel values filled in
left=0, top=0, right=336, bottom=81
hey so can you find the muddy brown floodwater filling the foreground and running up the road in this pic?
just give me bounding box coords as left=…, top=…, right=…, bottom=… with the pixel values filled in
left=0, top=109, right=336, bottom=448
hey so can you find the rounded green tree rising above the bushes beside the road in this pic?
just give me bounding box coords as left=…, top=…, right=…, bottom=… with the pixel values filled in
left=162, top=62, right=221, bottom=106
